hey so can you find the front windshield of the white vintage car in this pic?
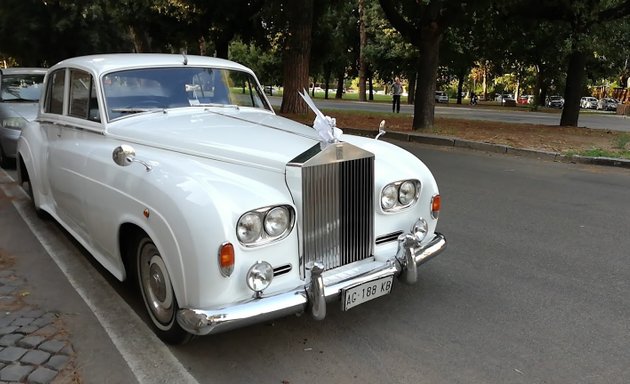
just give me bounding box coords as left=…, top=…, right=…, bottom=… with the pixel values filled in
left=102, top=67, right=271, bottom=120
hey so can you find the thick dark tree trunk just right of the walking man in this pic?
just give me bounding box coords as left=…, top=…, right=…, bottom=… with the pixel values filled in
left=412, top=25, right=442, bottom=131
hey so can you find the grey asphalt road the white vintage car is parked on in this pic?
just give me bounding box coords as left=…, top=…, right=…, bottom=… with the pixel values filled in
left=2, top=142, right=630, bottom=384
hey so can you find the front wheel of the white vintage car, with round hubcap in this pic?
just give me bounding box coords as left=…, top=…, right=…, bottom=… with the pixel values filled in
left=136, top=237, right=193, bottom=344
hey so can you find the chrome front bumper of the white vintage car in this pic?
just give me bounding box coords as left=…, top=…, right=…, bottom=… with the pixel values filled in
left=177, top=233, right=446, bottom=335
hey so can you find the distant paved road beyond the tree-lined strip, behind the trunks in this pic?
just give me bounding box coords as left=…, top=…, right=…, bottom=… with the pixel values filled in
left=270, top=96, right=630, bottom=132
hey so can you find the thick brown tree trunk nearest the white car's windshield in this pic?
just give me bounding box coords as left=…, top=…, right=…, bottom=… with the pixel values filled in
left=280, top=0, right=314, bottom=114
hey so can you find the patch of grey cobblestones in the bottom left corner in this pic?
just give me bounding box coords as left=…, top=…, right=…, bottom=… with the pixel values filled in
left=0, top=268, right=81, bottom=384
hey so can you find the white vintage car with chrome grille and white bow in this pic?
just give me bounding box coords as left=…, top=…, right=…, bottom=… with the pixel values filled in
left=17, top=54, right=446, bottom=343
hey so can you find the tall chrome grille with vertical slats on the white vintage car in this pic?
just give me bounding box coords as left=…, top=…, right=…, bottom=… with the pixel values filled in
left=302, top=148, right=374, bottom=270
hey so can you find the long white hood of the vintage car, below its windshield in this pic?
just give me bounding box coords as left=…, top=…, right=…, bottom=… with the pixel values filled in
left=107, top=107, right=319, bottom=172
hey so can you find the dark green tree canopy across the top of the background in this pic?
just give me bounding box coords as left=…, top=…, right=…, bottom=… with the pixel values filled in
left=0, top=0, right=630, bottom=124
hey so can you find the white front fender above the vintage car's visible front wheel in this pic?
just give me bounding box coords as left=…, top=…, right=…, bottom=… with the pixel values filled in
left=85, top=143, right=297, bottom=307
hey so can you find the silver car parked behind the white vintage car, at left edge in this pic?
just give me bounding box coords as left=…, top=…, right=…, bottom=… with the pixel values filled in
left=0, top=67, right=46, bottom=168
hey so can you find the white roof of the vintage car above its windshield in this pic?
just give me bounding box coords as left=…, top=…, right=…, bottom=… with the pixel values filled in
left=51, top=53, right=251, bottom=73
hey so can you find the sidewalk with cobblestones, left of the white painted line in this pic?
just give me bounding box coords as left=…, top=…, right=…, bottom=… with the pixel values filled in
left=0, top=177, right=137, bottom=384
